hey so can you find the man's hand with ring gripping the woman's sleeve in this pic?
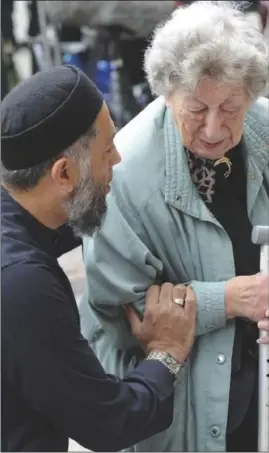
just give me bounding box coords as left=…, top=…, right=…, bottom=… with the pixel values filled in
left=126, top=283, right=196, bottom=363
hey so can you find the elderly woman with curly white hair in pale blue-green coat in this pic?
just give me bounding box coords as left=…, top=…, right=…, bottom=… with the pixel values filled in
left=82, top=1, right=269, bottom=451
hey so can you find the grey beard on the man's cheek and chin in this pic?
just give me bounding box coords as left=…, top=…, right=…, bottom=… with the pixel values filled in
left=64, top=178, right=107, bottom=236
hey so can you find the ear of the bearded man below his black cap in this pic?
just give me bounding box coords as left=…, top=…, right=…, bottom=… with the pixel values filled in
left=51, top=157, right=79, bottom=193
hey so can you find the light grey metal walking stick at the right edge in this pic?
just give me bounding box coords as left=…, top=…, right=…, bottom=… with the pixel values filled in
left=252, top=226, right=269, bottom=452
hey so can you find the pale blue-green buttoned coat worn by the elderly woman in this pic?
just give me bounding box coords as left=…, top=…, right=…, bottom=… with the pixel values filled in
left=81, top=98, right=269, bottom=451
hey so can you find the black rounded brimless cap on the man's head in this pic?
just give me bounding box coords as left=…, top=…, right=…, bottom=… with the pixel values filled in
left=0, top=65, right=103, bottom=170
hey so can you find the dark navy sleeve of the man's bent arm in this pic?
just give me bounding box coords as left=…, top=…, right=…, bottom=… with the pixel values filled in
left=2, top=263, right=174, bottom=451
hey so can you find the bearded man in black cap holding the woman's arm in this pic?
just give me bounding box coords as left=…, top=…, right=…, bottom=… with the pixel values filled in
left=0, top=66, right=196, bottom=452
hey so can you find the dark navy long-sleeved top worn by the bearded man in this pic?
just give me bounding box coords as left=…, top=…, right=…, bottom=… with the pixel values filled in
left=1, top=188, right=174, bottom=452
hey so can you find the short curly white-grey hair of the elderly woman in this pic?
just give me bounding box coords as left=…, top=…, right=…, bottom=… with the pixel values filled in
left=144, top=1, right=269, bottom=100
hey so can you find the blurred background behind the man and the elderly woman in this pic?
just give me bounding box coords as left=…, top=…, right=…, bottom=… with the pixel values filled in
left=1, top=0, right=269, bottom=451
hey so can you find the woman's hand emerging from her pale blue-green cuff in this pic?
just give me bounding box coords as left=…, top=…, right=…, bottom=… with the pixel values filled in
left=225, top=274, right=269, bottom=323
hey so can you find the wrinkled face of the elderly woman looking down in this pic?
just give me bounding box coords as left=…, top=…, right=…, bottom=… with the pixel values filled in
left=167, top=77, right=250, bottom=160
